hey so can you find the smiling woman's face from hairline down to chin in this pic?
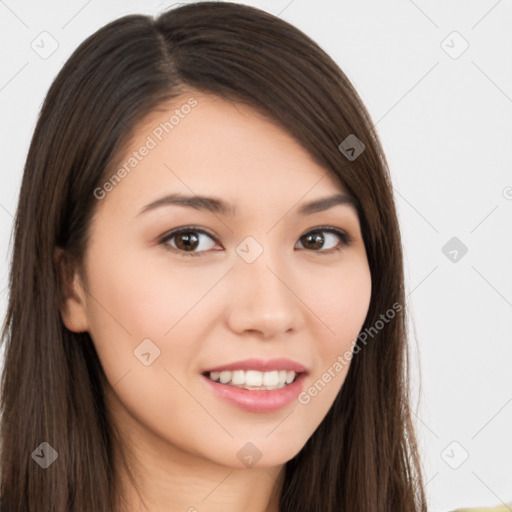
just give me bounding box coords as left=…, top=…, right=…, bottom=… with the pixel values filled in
left=63, top=93, right=371, bottom=468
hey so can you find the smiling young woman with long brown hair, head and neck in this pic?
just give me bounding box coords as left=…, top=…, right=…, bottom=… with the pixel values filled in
left=1, top=2, right=426, bottom=512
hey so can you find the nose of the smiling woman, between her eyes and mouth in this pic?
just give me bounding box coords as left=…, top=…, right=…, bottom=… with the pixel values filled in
left=228, top=250, right=304, bottom=339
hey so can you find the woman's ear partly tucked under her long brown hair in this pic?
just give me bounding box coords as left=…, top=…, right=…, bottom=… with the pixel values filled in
left=54, top=247, right=88, bottom=332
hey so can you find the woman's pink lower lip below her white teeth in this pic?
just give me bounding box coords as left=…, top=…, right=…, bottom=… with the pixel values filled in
left=202, top=373, right=306, bottom=412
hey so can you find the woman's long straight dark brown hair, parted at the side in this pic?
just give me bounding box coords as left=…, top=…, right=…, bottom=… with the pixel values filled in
left=0, top=2, right=426, bottom=512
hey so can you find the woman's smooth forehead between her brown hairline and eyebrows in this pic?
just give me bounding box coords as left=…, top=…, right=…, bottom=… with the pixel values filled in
left=95, top=91, right=348, bottom=217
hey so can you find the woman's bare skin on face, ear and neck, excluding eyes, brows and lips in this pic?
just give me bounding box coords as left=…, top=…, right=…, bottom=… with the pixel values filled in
left=58, top=91, right=371, bottom=512
